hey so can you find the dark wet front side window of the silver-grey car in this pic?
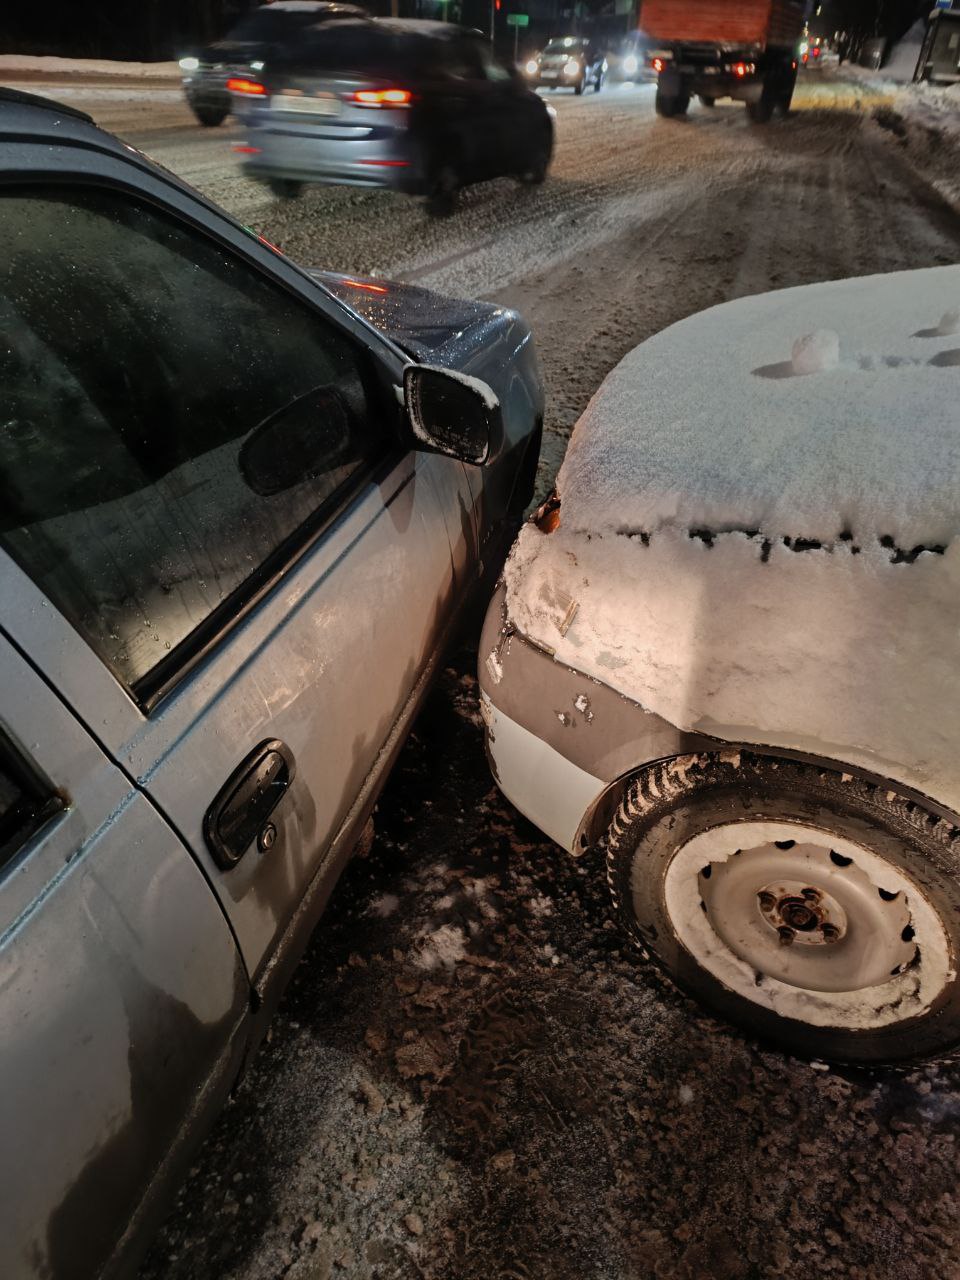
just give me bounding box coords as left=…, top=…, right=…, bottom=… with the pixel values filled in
left=0, top=188, right=387, bottom=686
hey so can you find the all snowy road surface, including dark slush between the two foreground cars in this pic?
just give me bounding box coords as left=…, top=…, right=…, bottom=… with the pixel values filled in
left=11, top=67, right=960, bottom=1280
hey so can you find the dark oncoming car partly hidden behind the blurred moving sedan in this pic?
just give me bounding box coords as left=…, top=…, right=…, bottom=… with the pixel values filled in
left=180, top=0, right=366, bottom=128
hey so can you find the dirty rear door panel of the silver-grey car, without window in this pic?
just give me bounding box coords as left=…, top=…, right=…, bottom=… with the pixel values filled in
left=0, top=635, right=248, bottom=1280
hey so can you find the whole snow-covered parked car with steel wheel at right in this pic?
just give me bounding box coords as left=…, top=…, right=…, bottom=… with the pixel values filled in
left=480, top=266, right=960, bottom=1064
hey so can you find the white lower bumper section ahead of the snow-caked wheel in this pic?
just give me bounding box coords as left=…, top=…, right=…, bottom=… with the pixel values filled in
left=480, top=694, right=607, bottom=854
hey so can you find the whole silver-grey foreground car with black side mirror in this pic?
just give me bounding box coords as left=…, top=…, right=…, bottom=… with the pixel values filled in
left=0, top=90, right=543, bottom=1280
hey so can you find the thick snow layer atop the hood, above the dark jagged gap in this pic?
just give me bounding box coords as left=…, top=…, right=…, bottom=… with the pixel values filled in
left=557, top=266, right=960, bottom=548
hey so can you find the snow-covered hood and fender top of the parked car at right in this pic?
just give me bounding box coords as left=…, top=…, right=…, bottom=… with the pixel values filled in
left=506, top=266, right=960, bottom=808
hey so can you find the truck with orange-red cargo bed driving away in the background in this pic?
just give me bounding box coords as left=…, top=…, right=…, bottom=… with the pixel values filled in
left=640, top=0, right=805, bottom=124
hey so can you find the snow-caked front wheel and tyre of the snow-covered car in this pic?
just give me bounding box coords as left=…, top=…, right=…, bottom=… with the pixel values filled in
left=607, top=750, right=960, bottom=1066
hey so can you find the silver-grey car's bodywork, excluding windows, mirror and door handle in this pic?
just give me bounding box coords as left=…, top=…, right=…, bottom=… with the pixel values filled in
left=0, top=95, right=543, bottom=1280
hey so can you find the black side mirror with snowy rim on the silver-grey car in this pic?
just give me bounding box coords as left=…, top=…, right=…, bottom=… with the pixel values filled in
left=403, top=365, right=503, bottom=466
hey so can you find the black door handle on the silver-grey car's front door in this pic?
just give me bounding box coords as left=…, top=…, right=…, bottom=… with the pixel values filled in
left=204, top=739, right=297, bottom=870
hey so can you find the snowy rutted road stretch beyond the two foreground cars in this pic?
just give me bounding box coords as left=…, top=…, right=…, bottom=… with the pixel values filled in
left=41, top=73, right=960, bottom=489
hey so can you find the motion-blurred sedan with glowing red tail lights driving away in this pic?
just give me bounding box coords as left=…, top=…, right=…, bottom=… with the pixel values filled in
left=230, top=19, right=553, bottom=214
